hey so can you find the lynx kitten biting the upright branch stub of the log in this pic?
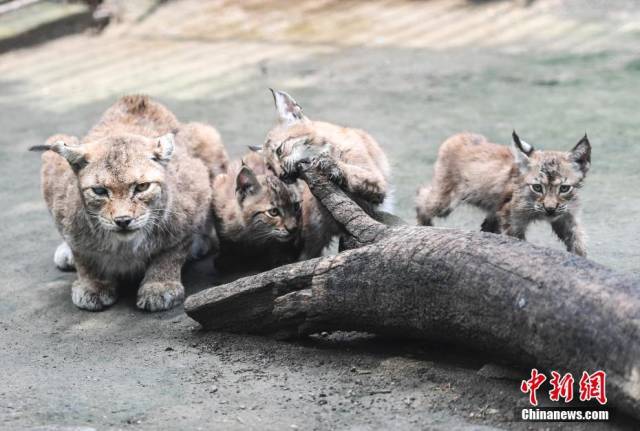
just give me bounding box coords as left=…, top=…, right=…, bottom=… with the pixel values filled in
left=253, top=90, right=390, bottom=260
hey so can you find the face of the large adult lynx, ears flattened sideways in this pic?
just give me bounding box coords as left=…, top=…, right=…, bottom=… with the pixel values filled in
left=51, top=135, right=173, bottom=241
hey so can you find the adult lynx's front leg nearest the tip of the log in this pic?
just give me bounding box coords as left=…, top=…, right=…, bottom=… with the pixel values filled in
left=136, top=243, right=190, bottom=311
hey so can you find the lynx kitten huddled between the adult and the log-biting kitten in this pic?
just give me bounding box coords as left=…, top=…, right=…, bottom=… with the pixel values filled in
left=212, top=152, right=302, bottom=271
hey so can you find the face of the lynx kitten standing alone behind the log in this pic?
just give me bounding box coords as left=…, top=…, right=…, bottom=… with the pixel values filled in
left=513, top=132, right=591, bottom=218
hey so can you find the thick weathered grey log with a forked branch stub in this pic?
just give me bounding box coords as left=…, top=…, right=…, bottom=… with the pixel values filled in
left=185, top=159, right=640, bottom=417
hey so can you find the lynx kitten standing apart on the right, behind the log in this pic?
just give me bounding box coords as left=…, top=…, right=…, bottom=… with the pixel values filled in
left=417, top=131, right=591, bottom=256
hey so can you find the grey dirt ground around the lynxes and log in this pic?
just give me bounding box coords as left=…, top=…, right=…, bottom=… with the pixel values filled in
left=0, top=2, right=640, bottom=430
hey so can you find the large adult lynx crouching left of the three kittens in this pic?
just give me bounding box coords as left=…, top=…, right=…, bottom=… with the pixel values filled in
left=39, top=96, right=226, bottom=311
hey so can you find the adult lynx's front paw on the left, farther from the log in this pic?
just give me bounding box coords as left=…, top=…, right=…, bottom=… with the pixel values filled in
left=71, top=258, right=118, bottom=311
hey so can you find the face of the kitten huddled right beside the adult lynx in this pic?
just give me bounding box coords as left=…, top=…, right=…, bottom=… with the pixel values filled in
left=236, top=166, right=302, bottom=243
